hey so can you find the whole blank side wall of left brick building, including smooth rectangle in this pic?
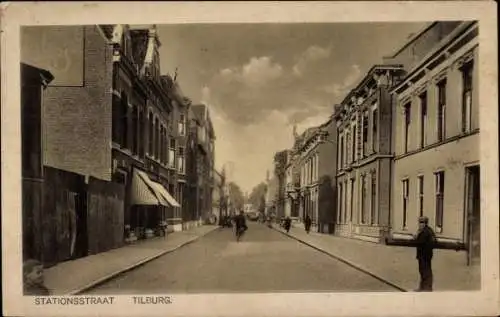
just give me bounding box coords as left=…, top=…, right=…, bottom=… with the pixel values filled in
left=21, top=26, right=113, bottom=180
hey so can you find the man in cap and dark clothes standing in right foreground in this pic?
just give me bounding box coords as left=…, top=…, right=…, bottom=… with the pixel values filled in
left=414, top=217, right=437, bottom=292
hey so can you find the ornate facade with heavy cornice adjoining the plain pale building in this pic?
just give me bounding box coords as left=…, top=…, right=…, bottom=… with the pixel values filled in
left=335, top=65, right=404, bottom=242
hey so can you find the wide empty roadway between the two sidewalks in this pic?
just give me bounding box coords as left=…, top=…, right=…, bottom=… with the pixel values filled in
left=87, top=223, right=397, bottom=295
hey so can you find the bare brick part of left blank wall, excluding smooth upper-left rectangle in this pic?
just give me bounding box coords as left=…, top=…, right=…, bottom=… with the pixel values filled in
left=32, top=26, right=112, bottom=180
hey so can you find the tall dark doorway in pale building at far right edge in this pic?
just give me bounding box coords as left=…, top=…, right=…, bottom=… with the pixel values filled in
left=465, top=166, right=481, bottom=265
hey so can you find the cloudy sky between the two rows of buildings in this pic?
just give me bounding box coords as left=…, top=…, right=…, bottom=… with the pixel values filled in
left=158, top=23, right=425, bottom=192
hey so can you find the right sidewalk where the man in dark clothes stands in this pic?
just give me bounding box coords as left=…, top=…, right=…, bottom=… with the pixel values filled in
left=273, top=226, right=481, bottom=291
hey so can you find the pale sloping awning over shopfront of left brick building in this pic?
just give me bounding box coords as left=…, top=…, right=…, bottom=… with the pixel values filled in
left=131, top=169, right=180, bottom=207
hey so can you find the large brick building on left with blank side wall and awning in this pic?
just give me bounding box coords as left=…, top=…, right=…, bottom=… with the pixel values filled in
left=22, top=25, right=181, bottom=243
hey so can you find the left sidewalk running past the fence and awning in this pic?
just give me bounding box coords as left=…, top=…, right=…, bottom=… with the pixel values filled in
left=44, top=225, right=219, bottom=295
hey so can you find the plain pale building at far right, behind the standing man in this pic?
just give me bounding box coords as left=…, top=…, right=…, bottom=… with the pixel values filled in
left=391, top=22, right=480, bottom=263
